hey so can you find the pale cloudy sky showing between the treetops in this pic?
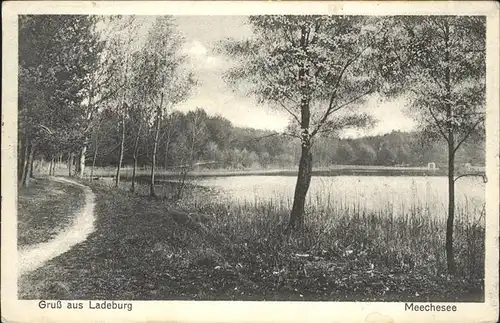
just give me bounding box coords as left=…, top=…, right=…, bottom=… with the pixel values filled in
left=153, top=16, right=414, bottom=137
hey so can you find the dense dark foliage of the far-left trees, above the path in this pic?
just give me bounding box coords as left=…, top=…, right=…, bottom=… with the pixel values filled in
left=19, top=15, right=101, bottom=154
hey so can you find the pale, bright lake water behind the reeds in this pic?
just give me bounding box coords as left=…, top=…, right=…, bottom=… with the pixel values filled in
left=196, top=176, right=485, bottom=218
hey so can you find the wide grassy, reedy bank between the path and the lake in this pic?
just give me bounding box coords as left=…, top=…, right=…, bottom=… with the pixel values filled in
left=20, top=183, right=484, bottom=301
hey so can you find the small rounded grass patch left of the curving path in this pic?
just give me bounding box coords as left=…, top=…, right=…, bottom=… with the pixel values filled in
left=17, top=178, right=85, bottom=248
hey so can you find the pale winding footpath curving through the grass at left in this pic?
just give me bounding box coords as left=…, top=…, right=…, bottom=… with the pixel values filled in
left=18, top=177, right=95, bottom=275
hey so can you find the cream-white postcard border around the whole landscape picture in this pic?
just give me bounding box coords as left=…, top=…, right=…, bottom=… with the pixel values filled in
left=1, top=1, right=500, bottom=322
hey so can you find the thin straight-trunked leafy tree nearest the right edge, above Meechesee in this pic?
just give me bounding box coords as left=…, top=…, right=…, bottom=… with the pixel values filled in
left=379, top=16, right=486, bottom=274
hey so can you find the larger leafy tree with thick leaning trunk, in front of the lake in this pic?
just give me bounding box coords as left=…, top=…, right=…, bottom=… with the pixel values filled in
left=222, top=16, right=386, bottom=229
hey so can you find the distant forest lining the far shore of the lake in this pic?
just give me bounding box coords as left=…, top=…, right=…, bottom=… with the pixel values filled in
left=87, top=109, right=485, bottom=169
